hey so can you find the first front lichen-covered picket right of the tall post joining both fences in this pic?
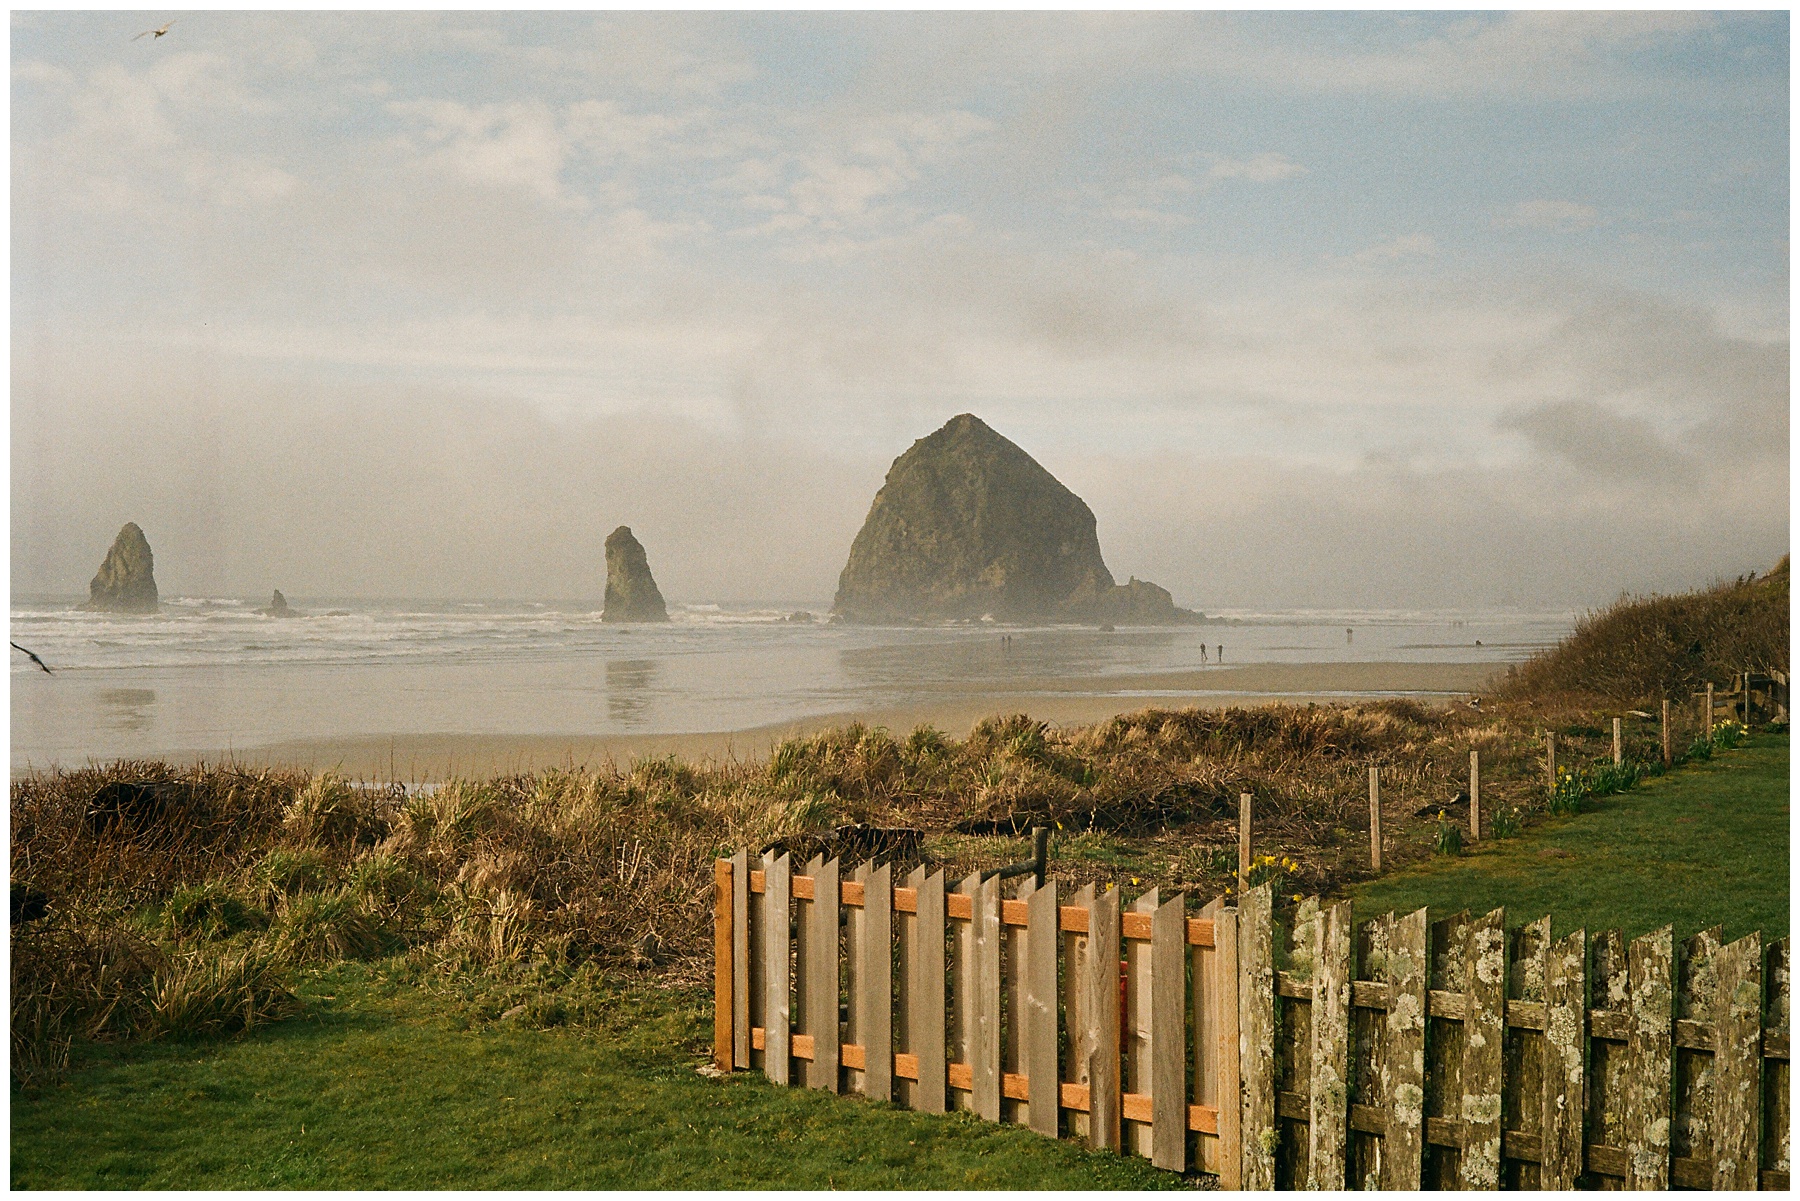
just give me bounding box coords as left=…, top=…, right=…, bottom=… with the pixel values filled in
left=1307, top=900, right=1352, bottom=1190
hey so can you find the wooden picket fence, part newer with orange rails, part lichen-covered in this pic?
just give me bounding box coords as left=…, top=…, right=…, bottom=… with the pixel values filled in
left=713, top=852, right=1789, bottom=1190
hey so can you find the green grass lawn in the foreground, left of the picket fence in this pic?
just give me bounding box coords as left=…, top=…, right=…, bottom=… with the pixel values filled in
left=13, top=965, right=1188, bottom=1188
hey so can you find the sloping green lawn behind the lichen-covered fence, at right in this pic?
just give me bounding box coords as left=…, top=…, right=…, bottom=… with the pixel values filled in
left=1352, top=735, right=1787, bottom=940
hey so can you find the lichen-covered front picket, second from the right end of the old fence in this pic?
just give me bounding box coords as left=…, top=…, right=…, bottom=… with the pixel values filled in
left=1625, top=926, right=1676, bottom=1188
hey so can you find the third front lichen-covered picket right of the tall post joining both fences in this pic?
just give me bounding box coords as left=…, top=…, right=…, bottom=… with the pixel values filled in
left=1458, top=909, right=1507, bottom=1188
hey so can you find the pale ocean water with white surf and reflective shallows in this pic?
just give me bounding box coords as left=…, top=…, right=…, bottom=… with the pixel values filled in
left=11, top=596, right=1575, bottom=774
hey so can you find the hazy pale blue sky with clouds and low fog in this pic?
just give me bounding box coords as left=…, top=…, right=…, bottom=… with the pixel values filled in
left=11, top=13, right=1789, bottom=609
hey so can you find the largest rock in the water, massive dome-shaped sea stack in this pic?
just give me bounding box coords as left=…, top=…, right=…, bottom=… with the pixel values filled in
left=832, top=412, right=1202, bottom=625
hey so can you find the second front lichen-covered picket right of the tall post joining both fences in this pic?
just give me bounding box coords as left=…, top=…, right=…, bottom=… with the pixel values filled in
left=1381, top=909, right=1431, bottom=1192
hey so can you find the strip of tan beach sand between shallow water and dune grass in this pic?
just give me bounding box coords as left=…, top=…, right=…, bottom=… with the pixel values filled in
left=182, top=663, right=1505, bottom=783
